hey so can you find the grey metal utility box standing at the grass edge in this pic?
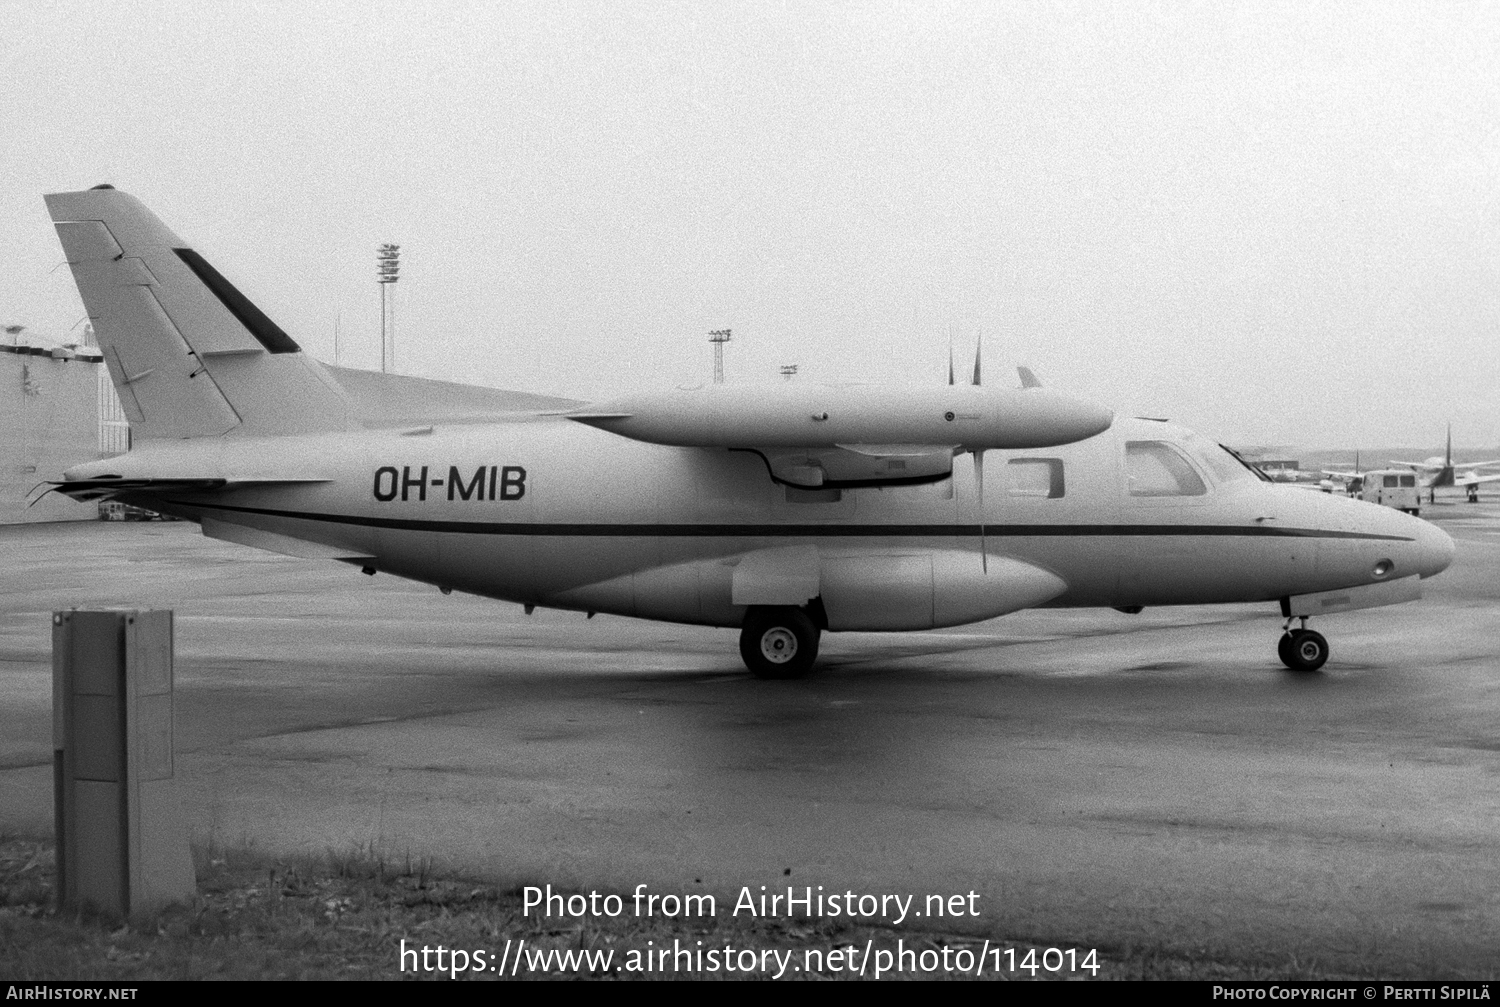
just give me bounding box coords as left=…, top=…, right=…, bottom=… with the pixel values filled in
left=53, top=609, right=197, bottom=915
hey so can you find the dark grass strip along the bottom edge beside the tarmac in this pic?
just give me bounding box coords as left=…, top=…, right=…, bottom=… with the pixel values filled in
left=0, top=839, right=1476, bottom=981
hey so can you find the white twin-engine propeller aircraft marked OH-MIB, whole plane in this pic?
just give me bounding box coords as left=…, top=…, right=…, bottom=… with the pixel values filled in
left=47, top=186, right=1454, bottom=678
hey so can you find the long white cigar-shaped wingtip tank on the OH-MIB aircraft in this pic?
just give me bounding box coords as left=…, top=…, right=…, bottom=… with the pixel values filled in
left=566, top=384, right=1115, bottom=450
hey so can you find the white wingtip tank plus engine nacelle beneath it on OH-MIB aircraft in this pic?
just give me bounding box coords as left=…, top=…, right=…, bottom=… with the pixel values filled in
left=560, top=384, right=1115, bottom=488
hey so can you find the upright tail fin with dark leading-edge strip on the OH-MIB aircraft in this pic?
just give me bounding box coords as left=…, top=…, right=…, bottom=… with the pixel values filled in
left=47, top=186, right=356, bottom=438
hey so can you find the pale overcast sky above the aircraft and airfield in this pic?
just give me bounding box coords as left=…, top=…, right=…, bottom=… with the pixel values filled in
left=0, top=0, right=1500, bottom=446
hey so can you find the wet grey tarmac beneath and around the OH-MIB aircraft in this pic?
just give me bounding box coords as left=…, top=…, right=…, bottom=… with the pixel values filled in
left=0, top=501, right=1500, bottom=974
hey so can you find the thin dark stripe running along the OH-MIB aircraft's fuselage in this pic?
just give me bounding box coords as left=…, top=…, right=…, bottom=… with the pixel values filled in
left=164, top=500, right=1413, bottom=542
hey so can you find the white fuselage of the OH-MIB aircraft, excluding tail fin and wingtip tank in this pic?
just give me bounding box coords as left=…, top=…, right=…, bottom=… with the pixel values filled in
left=85, top=417, right=1452, bottom=629
